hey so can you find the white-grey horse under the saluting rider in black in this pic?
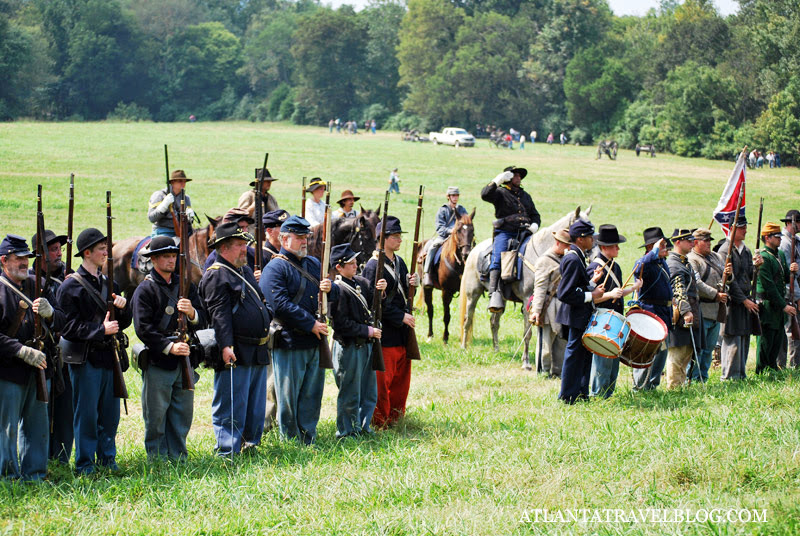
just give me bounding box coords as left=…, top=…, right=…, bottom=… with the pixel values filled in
left=459, top=206, right=592, bottom=370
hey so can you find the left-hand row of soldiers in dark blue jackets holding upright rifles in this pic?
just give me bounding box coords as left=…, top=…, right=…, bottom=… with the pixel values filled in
left=0, top=177, right=417, bottom=480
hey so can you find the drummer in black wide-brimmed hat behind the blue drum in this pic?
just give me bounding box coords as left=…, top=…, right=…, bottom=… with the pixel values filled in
left=586, top=224, right=642, bottom=398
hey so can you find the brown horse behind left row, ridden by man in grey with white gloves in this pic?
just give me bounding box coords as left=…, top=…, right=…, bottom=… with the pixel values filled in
left=112, top=220, right=216, bottom=299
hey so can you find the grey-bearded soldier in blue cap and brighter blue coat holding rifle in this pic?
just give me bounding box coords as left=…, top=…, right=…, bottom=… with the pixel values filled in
left=260, top=216, right=339, bottom=445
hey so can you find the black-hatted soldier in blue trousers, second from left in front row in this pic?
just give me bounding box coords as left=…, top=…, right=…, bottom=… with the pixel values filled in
left=58, top=228, right=131, bottom=474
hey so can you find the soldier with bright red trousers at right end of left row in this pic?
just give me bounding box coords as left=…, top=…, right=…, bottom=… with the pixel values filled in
left=364, top=216, right=418, bottom=428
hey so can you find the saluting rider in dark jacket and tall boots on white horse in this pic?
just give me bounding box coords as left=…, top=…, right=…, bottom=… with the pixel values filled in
left=481, top=166, right=542, bottom=313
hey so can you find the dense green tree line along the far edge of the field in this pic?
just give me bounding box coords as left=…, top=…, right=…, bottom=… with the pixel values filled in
left=0, top=0, right=800, bottom=164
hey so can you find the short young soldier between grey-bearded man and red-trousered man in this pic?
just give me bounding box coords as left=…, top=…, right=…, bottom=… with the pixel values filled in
left=330, top=244, right=386, bottom=438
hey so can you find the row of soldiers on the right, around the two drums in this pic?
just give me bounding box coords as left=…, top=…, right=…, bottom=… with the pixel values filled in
left=529, top=210, right=800, bottom=403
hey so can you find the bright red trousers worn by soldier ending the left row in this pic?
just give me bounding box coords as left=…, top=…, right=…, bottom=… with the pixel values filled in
left=372, top=346, right=411, bottom=428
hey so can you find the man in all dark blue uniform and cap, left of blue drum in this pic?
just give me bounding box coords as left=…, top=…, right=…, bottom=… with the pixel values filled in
left=556, top=219, right=604, bottom=404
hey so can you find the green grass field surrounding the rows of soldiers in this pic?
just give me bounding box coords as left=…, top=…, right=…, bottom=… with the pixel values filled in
left=0, top=123, right=800, bottom=535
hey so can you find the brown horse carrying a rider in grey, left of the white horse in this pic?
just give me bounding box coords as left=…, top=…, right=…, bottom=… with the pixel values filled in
left=417, top=209, right=475, bottom=344
